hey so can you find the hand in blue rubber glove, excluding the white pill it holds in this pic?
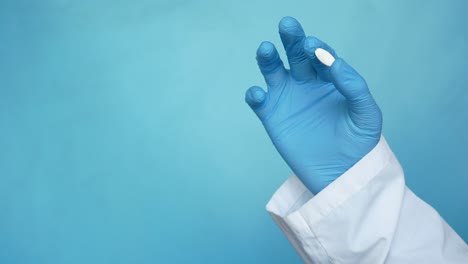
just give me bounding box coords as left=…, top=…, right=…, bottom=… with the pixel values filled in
left=245, top=17, right=382, bottom=194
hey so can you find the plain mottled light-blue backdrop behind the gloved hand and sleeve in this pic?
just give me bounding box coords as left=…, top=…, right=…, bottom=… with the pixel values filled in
left=0, top=0, right=468, bottom=264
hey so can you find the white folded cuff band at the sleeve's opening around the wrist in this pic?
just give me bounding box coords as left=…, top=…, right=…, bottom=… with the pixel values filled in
left=266, top=136, right=394, bottom=229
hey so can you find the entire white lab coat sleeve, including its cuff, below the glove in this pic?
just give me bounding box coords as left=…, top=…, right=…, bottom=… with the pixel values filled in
left=267, top=137, right=468, bottom=264
